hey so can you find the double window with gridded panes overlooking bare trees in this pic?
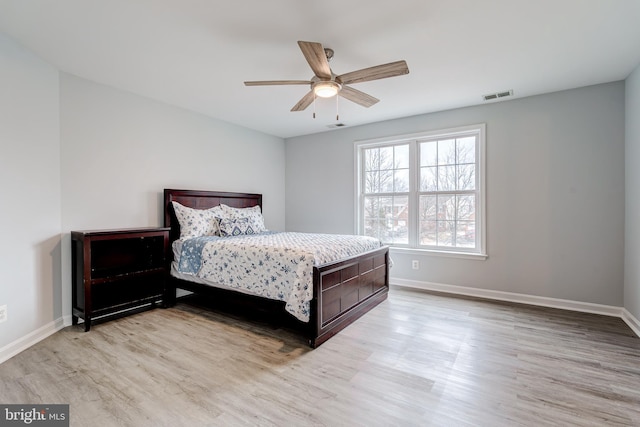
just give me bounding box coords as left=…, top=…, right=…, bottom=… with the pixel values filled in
left=355, top=125, right=485, bottom=255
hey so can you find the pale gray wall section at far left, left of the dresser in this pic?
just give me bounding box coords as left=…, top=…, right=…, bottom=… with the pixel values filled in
left=0, top=34, right=62, bottom=352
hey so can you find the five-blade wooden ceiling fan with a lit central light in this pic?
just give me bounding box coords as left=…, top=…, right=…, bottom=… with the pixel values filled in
left=244, top=41, right=409, bottom=111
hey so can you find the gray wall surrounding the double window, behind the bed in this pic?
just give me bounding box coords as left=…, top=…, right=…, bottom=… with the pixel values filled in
left=286, top=82, right=625, bottom=307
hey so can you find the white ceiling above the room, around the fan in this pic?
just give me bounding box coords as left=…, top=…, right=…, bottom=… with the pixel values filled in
left=0, top=0, right=640, bottom=138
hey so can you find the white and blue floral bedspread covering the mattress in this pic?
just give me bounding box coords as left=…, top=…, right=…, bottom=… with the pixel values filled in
left=172, top=232, right=382, bottom=322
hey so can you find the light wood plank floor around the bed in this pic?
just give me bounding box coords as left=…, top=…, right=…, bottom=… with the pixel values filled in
left=0, top=288, right=640, bottom=427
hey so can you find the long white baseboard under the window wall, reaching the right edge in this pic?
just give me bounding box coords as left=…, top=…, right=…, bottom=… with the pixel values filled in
left=391, top=279, right=640, bottom=324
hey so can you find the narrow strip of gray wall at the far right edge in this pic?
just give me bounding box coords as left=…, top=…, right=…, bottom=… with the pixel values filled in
left=624, top=66, right=640, bottom=319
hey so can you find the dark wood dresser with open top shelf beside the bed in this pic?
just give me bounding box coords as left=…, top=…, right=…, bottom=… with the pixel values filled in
left=71, top=227, right=170, bottom=331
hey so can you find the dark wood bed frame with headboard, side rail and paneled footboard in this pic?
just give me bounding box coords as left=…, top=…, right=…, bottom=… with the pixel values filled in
left=164, top=189, right=389, bottom=348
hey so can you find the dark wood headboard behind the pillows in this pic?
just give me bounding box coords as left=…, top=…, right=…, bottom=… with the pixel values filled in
left=164, top=189, right=262, bottom=241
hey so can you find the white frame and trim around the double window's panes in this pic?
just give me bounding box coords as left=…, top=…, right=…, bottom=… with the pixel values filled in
left=354, top=123, right=487, bottom=259
